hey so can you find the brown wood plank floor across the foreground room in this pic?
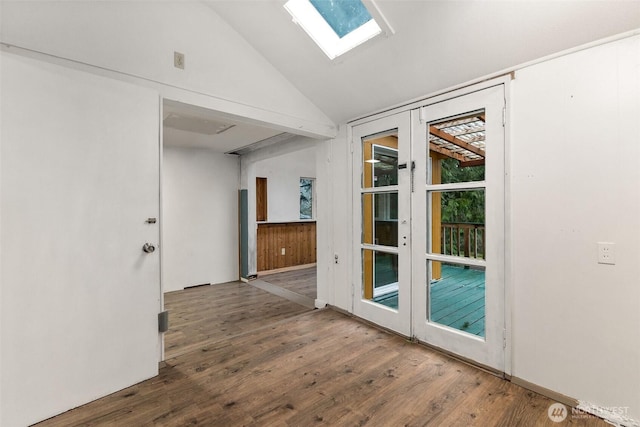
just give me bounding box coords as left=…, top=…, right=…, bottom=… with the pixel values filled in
left=39, top=284, right=606, bottom=427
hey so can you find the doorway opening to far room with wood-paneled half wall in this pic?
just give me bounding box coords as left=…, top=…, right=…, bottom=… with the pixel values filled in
left=249, top=144, right=317, bottom=307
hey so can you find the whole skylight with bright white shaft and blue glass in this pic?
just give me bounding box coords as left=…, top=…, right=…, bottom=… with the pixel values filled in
left=284, top=0, right=382, bottom=59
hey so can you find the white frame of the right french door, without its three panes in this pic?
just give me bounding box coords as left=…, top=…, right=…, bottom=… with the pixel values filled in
left=411, top=85, right=506, bottom=372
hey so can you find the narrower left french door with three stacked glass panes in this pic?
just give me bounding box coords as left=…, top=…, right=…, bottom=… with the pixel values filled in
left=352, top=112, right=411, bottom=336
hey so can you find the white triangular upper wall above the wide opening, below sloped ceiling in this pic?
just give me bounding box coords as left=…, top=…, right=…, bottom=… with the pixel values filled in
left=1, top=1, right=335, bottom=136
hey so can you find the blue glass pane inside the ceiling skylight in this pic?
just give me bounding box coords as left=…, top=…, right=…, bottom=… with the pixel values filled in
left=309, top=0, right=372, bottom=38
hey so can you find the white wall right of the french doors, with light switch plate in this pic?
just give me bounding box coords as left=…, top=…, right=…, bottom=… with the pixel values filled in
left=510, top=36, right=640, bottom=420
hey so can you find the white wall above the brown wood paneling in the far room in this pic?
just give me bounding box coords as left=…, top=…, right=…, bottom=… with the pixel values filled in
left=254, top=147, right=316, bottom=222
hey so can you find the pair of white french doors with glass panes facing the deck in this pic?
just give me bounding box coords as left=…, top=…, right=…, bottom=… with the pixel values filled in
left=352, top=85, right=505, bottom=371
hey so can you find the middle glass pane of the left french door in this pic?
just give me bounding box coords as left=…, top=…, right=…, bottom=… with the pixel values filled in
left=362, top=192, right=398, bottom=247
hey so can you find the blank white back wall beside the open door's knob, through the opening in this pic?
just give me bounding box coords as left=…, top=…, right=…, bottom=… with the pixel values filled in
left=162, top=145, right=240, bottom=292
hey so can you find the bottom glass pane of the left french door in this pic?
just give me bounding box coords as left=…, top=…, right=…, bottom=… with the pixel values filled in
left=362, top=249, right=398, bottom=310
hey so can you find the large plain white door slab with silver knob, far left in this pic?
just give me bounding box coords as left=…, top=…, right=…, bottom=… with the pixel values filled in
left=0, top=52, right=160, bottom=427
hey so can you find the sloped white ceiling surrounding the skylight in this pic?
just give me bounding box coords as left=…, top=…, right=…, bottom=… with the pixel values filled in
left=204, top=0, right=640, bottom=123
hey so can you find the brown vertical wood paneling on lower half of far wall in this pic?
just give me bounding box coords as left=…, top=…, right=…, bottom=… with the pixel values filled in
left=258, top=222, right=316, bottom=271
